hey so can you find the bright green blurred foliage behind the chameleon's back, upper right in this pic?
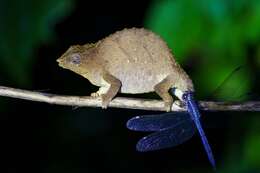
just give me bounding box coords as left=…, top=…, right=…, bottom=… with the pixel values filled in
left=146, top=0, right=260, bottom=99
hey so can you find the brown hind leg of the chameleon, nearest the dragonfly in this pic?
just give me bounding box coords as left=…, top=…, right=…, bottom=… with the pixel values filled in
left=154, top=77, right=173, bottom=112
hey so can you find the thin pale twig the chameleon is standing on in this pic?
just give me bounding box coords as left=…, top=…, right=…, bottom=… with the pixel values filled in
left=0, top=86, right=260, bottom=111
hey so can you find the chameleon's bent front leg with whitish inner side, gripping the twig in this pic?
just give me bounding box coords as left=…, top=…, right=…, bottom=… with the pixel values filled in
left=91, top=72, right=121, bottom=109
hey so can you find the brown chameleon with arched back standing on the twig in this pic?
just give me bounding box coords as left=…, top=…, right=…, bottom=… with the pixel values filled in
left=57, top=28, right=194, bottom=111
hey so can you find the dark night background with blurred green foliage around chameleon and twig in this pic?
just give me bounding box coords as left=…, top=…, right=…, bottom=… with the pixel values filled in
left=0, top=0, right=260, bottom=173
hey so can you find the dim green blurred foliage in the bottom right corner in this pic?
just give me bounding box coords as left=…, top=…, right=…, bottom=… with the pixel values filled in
left=221, top=113, right=260, bottom=173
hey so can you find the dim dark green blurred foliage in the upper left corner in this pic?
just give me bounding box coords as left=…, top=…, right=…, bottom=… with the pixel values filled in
left=0, top=0, right=72, bottom=86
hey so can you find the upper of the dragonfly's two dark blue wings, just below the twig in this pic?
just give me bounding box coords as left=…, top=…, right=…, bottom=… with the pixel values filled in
left=126, top=112, right=190, bottom=131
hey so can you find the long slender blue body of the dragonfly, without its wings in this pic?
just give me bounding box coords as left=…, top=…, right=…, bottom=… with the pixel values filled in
left=184, top=93, right=216, bottom=170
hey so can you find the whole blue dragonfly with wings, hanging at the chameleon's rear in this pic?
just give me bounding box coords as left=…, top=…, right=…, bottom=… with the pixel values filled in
left=127, top=89, right=216, bottom=170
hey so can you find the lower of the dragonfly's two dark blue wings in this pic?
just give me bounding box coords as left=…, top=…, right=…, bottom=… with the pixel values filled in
left=136, top=121, right=195, bottom=152
